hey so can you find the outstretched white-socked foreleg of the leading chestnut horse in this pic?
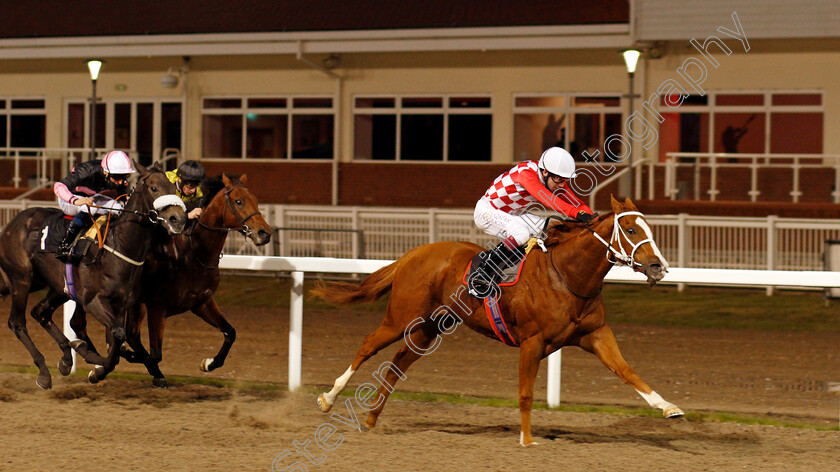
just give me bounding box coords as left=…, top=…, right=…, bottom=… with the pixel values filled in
left=580, top=326, right=684, bottom=418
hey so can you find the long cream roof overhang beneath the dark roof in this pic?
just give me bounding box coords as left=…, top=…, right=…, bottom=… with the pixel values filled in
left=0, top=24, right=632, bottom=59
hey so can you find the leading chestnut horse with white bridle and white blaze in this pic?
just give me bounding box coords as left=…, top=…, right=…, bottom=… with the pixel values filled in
left=311, top=195, right=683, bottom=445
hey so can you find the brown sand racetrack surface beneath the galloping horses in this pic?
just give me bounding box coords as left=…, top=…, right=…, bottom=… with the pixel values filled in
left=0, top=299, right=840, bottom=472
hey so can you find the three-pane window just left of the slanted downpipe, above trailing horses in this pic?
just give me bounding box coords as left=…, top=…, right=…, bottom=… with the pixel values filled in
left=201, top=96, right=335, bottom=159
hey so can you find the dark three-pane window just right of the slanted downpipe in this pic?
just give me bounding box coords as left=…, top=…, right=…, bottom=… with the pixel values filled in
left=353, top=95, right=493, bottom=162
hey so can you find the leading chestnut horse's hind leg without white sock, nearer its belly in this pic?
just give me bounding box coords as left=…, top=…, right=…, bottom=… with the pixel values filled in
left=365, top=321, right=440, bottom=428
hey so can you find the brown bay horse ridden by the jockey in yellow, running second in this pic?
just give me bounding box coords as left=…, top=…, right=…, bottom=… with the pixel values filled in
left=70, top=174, right=272, bottom=387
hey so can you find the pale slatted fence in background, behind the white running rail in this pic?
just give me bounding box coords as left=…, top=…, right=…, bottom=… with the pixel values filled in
left=0, top=200, right=840, bottom=270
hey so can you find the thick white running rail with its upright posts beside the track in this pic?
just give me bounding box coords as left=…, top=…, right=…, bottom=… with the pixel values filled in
left=64, top=256, right=840, bottom=406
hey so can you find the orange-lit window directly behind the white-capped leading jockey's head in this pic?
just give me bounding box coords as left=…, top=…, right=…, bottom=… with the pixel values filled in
left=513, top=94, right=622, bottom=161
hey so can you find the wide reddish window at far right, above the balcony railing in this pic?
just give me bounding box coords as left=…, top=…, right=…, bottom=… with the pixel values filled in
left=659, top=91, right=823, bottom=160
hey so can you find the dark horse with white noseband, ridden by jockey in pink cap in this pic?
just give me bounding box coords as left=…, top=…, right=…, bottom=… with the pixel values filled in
left=0, top=162, right=186, bottom=389
